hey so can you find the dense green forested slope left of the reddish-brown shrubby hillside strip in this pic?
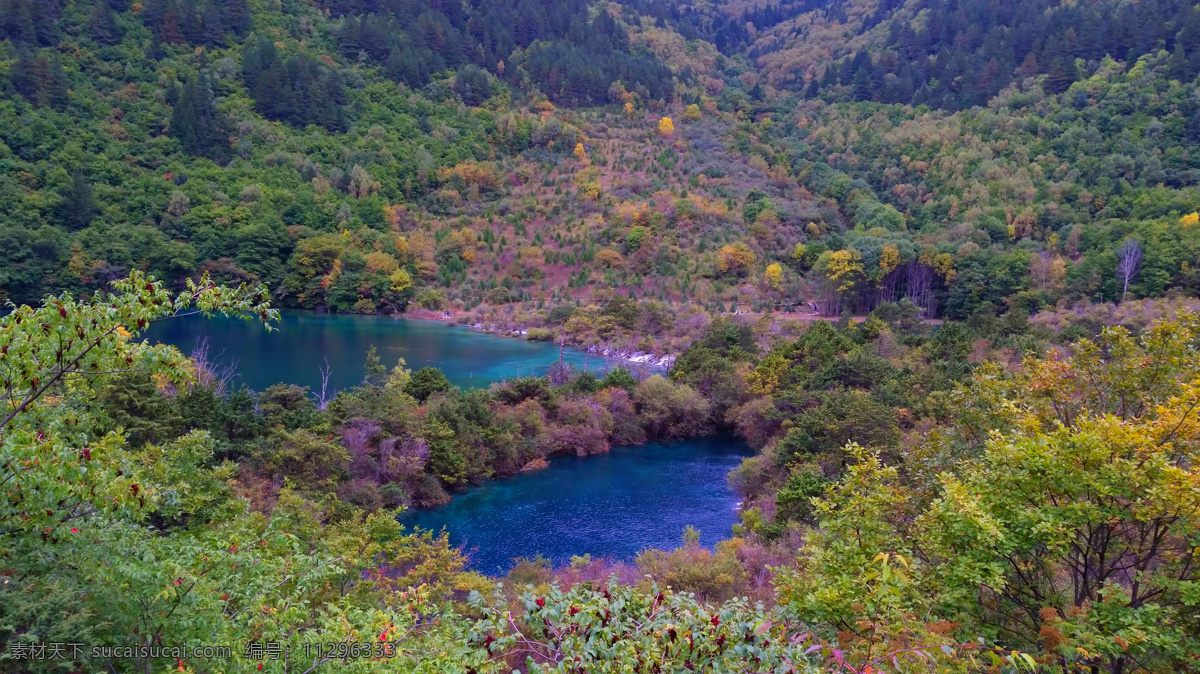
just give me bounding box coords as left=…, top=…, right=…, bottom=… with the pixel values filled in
left=0, top=0, right=673, bottom=306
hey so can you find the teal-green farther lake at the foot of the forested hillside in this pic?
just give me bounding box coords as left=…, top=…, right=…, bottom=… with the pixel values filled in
left=145, top=311, right=590, bottom=391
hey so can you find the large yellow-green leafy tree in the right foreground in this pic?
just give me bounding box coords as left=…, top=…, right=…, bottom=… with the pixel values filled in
left=776, top=313, right=1200, bottom=674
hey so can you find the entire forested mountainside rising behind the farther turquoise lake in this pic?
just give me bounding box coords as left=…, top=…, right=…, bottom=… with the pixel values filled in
left=0, top=0, right=1200, bottom=325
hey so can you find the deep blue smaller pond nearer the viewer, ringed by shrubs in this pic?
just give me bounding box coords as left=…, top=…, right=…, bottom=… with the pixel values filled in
left=401, top=437, right=752, bottom=574
